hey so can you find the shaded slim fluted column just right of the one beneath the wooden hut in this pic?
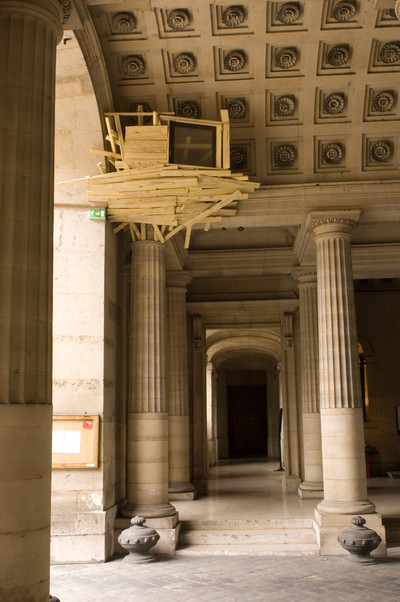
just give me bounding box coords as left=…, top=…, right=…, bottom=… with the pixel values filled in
left=167, top=271, right=195, bottom=500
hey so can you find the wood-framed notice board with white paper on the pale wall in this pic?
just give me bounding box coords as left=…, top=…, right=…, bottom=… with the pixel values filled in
left=52, top=414, right=99, bottom=468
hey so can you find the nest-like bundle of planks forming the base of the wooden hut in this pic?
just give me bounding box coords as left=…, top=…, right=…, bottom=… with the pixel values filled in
left=87, top=165, right=259, bottom=246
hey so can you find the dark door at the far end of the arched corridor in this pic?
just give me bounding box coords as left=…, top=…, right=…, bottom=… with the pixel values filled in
left=227, top=385, right=268, bottom=457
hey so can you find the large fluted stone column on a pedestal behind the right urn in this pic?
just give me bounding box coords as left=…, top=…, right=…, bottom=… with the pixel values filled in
left=308, top=210, right=384, bottom=554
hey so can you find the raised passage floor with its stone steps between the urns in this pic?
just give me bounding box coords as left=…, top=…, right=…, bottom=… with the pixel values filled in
left=174, top=457, right=400, bottom=556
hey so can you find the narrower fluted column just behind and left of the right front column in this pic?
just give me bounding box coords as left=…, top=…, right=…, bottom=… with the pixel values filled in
left=293, top=267, right=323, bottom=498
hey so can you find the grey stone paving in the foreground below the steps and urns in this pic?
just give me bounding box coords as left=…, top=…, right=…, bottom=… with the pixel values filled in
left=51, top=556, right=400, bottom=602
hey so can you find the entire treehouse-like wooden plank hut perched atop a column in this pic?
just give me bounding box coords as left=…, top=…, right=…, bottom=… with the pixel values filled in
left=61, top=107, right=259, bottom=247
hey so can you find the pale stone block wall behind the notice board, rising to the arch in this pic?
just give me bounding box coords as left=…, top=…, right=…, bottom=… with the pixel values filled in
left=52, top=32, right=119, bottom=562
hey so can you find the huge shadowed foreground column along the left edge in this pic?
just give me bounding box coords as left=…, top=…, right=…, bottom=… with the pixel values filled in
left=0, top=0, right=63, bottom=602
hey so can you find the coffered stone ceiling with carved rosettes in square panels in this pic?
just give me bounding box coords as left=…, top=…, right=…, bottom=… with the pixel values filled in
left=76, top=0, right=400, bottom=185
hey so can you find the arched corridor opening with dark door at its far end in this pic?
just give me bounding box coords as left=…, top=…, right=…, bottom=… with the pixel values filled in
left=207, top=329, right=280, bottom=464
